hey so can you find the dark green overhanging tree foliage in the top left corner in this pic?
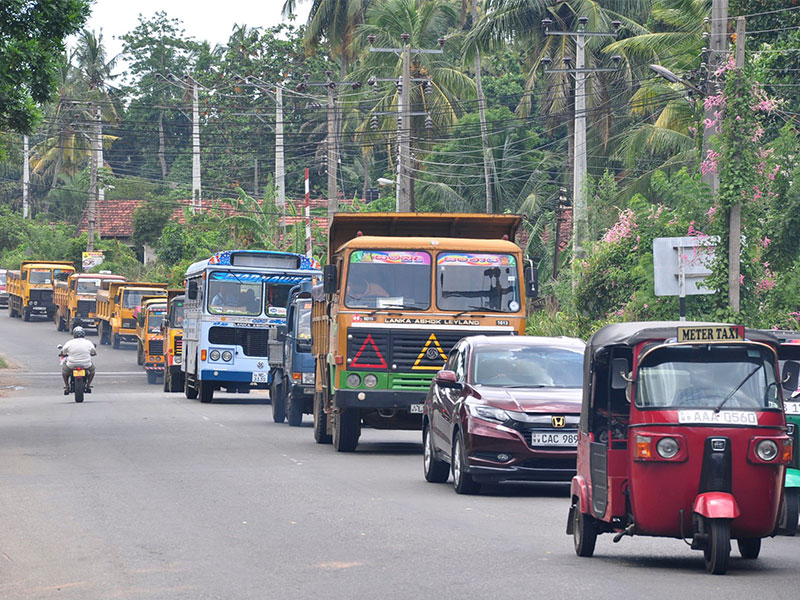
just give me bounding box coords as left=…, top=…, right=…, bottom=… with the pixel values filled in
left=0, top=0, right=89, bottom=133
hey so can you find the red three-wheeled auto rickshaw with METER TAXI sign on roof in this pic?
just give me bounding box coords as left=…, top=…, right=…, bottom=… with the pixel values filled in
left=567, top=322, right=800, bottom=574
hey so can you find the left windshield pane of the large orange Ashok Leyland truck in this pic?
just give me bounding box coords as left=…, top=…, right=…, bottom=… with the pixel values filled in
left=344, top=250, right=431, bottom=310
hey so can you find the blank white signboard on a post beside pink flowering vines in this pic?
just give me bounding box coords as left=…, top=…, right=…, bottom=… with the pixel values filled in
left=653, top=236, right=719, bottom=296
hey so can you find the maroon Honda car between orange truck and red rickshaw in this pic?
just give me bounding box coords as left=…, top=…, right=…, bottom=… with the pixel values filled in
left=422, top=336, right=585, bottom=494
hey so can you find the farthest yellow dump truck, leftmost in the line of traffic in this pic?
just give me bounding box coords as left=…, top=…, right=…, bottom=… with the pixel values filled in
left=8, top=260, right=75, bottom=321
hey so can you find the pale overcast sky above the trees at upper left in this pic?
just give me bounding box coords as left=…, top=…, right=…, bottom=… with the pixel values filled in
left=76, top=0, right=312, bottom=75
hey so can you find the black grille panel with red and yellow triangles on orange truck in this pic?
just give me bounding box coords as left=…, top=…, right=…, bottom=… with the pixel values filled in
left=347, top=327, right=508, bottom=375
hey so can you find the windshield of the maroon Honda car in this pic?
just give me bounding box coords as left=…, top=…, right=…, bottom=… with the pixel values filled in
left=473, top=344, right=583, bottom=388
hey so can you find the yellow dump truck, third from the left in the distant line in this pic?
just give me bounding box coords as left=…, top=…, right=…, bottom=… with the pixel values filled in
left=97, top=281, right=167, bottom=348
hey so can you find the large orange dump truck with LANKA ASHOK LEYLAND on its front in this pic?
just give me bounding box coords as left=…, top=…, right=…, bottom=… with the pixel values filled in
left=312, top=213, right=535, bottom=452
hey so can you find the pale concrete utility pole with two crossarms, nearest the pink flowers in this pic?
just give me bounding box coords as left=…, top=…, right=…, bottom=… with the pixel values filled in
left=542, top=17, right=621, bottom=264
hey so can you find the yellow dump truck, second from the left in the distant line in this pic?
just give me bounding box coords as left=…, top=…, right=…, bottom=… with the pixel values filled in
left=53, top=273, right=125, bottom=331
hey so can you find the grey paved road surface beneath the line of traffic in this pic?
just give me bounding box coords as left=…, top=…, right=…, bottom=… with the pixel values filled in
left=0, top=311, right=800, bottom=600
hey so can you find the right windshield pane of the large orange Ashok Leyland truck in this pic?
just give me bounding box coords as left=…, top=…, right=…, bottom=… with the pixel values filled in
left=436, top=252, right=520, bottom=312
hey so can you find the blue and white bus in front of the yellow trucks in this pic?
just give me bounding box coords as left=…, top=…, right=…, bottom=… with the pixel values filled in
left=182, top=250, right=320, bottom=402
